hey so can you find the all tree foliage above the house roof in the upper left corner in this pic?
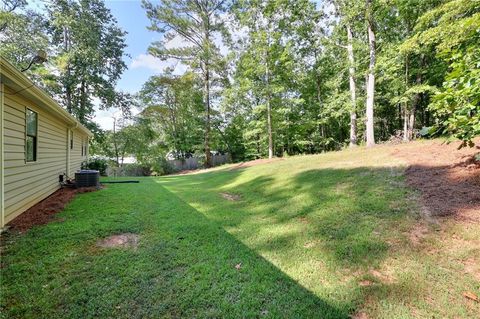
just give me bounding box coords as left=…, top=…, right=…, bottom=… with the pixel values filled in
left=0, top=0, right=128, bottom=126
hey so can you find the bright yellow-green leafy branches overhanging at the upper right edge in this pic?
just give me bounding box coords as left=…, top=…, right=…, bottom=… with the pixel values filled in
left=401, top=0, right=480, bottom=146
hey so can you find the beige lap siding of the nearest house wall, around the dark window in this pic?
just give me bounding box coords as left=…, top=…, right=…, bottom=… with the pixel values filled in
left=4, top=88, right=67, bottom=223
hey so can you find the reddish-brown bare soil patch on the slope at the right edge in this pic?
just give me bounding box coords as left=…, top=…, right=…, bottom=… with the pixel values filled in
left=393, top=139, right=480, bottom=222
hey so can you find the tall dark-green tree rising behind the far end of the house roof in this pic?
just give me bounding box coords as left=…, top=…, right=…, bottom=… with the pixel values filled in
left=45, top=0, right=126, bottom=124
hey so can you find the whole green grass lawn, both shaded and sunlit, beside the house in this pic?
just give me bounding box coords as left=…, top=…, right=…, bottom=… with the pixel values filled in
left=1, top=147, right=480, bottom=318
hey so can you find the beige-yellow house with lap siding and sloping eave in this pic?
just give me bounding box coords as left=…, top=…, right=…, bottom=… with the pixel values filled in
left=0, top=57, right=92, bottom=228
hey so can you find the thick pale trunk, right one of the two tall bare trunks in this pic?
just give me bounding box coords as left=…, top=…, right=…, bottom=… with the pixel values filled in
left=366, top=0, right=375, bottom=146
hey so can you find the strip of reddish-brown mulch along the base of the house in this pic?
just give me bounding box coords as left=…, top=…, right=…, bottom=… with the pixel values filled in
left=8, top=187, right=97, bottom=232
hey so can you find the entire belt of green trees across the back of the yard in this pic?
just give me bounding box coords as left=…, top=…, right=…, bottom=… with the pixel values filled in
left=0, top=0, right=480, bottom=166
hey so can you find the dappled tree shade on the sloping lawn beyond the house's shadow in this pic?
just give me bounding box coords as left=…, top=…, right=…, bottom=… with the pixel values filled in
left=164, top=168, right=410, bottom=268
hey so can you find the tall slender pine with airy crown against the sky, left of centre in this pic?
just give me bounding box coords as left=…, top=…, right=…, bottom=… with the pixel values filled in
left=142, top=0, right=228, bottom=167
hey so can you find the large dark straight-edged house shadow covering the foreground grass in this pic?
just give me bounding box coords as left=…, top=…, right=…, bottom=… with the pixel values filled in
left=1, top=181, right=354, bottom=318
